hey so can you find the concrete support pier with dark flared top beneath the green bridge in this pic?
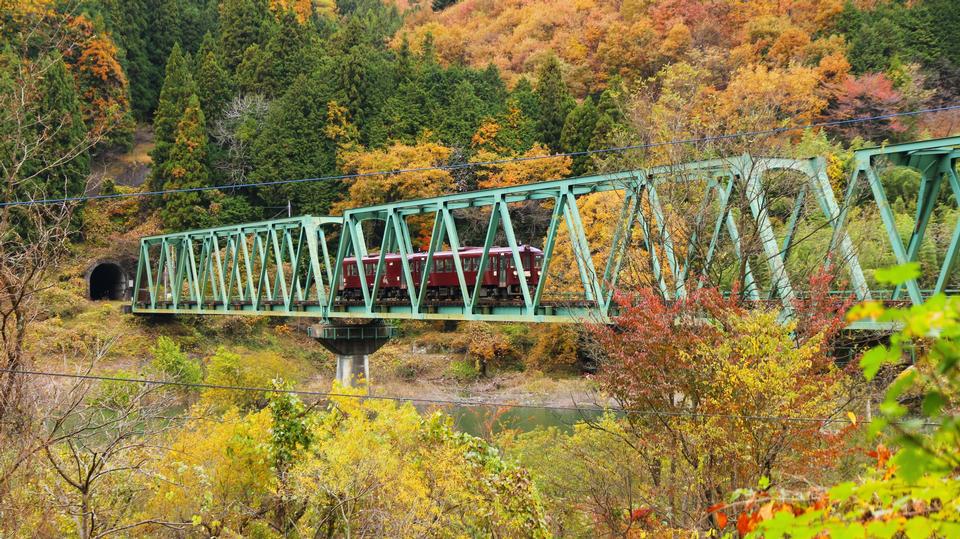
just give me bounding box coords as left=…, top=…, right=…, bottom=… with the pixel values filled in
left=307, top=320, right=393, bottom=387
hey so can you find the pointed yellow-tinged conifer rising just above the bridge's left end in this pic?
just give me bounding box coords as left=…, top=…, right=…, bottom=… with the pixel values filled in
left=160, top=94, right=212, bottom=230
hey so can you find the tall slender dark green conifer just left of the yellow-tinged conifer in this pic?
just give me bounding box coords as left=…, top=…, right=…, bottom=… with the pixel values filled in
left=151, top=44, right=197, bottom=189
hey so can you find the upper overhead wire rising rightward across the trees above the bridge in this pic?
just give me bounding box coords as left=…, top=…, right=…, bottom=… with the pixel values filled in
left=7, top=104, right=960, bottom=207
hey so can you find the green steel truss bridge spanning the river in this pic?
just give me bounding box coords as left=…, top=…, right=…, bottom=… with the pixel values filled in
left=132, top=137, right=960, bottom=322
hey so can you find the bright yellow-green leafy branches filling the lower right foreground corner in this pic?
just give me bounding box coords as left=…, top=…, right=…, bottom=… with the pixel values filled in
left=728, top=264, right=960, bottom=539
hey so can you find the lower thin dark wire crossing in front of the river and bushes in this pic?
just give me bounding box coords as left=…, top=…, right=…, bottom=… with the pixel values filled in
left=0, top=369, right=940, bottom=426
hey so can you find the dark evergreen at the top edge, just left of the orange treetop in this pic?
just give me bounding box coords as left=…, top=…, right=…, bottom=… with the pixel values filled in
left=220, top=0, right=273, bottom=71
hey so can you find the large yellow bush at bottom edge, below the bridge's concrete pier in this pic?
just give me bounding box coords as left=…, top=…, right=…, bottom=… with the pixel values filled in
left=291, top=388, right=545, bottom=537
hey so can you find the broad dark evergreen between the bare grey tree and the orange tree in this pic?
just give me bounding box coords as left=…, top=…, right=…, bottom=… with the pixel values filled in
left=250, top=73, right=342, bottom=215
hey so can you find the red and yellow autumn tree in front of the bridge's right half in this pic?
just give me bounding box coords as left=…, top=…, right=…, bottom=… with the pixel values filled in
left=594, top=290, right=847, bottom=526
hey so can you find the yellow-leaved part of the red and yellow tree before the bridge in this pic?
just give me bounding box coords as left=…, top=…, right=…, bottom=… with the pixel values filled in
left=687, top=310, right=844, bottom=479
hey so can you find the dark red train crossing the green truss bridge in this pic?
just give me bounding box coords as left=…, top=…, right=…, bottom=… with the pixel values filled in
left=340, top=245, right=543, bottom=299
